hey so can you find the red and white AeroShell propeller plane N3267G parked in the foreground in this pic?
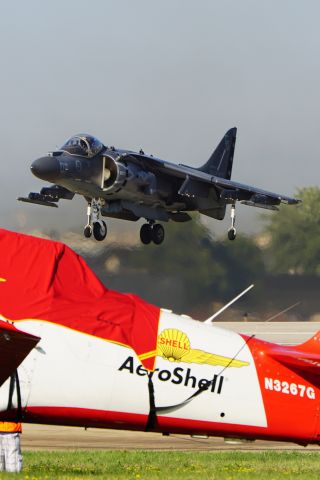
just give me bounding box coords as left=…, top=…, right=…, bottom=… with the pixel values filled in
left=0, top=229, right=320, bottom=445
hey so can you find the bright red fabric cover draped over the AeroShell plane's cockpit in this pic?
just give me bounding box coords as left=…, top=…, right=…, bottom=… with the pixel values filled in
left=0, top=229, right=160, bottom=370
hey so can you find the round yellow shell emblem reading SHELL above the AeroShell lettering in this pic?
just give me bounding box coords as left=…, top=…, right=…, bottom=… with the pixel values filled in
left=158, top=328, right=190, bottom=362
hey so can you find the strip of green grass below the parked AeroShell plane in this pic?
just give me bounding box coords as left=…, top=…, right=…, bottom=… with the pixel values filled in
left=0, top=450, right=320, bottom=480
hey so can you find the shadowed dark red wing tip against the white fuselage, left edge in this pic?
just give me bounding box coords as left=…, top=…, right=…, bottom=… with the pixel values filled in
left=0, top=320, right=40, bottom=386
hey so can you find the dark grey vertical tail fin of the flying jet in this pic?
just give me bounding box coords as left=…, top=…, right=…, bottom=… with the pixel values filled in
left=198, top=127, right=237, bottom=180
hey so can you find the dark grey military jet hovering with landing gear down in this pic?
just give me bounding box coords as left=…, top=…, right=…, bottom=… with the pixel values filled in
left=18, top=128, right=298, bottom=245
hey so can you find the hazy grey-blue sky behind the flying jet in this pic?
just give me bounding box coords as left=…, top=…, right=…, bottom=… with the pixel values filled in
left=0, top=0, right=320, bottom=235
